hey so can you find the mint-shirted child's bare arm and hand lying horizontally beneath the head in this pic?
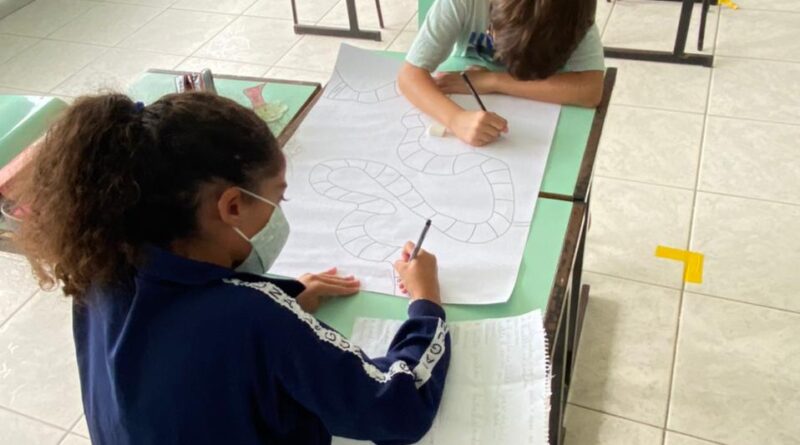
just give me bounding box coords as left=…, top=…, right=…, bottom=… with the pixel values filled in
left=435, top=70, right=604, bottom=108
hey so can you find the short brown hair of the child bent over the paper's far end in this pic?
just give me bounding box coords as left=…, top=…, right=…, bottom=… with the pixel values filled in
left=490, top=0, right=597, bottom=80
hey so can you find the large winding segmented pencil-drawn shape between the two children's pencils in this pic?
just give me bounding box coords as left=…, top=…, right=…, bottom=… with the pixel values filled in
left=309, top=110, right=514, bottom=276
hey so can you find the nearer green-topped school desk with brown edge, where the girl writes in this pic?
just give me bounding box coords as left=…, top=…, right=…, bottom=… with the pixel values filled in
left=316, top=198, right=586, bottom=445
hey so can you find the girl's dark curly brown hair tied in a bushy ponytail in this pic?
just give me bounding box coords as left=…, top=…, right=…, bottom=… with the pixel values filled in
left=16, top=93, right=284, bottom=300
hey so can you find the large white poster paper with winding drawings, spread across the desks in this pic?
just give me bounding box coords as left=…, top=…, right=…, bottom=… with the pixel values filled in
left=271, top=45, right=560, bottom=304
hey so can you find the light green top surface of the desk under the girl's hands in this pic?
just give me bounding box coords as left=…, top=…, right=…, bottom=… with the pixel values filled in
left=316, top=198, right=573, bottom=336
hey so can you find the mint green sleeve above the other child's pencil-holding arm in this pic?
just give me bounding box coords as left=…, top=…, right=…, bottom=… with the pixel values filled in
left=406, top=0, right=466, bottom=71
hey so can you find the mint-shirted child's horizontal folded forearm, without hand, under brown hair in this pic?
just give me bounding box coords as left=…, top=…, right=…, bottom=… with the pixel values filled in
left=492, top=71, right=603, bottom=108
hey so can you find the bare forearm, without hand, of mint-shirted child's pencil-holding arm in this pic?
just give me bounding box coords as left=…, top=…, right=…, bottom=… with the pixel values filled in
left=397, top=63, right=463, bottom=127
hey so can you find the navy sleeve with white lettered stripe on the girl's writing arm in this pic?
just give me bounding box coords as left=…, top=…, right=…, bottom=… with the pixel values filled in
left=265, top=284, right=450, bottom=445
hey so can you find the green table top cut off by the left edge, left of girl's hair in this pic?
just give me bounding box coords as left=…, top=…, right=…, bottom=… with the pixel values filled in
left=0, top=95, right=67, bottom=168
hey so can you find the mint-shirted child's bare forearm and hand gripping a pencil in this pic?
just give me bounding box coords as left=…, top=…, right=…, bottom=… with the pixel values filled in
left=397, top=62, right=508, bottom=146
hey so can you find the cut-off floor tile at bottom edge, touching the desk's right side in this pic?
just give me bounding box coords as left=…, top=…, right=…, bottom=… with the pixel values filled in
left=564, top=405, right=663, bottom=445
